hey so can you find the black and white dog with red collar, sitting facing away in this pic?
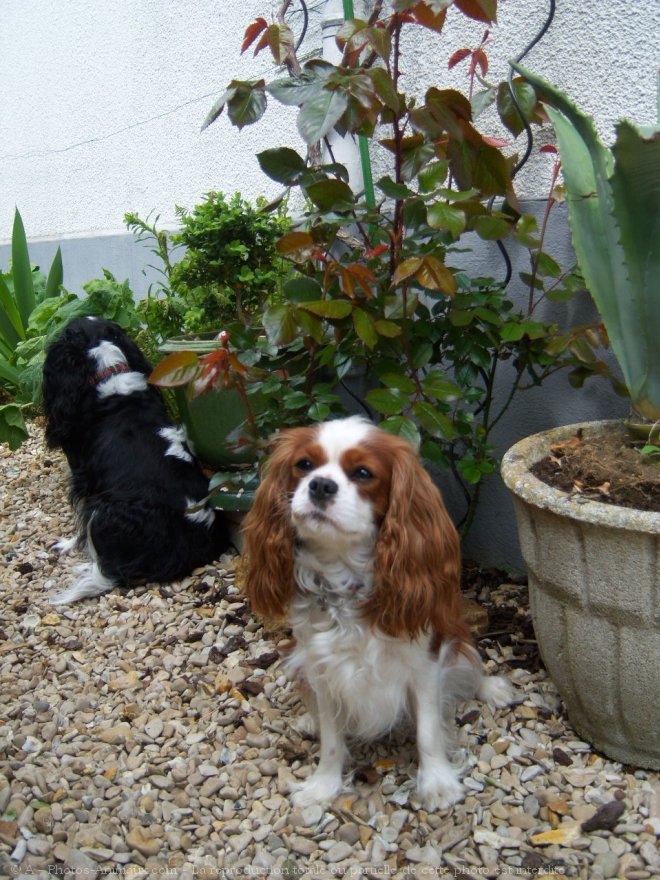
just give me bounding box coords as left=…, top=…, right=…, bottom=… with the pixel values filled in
left=43, top=317, right=230, bottom=604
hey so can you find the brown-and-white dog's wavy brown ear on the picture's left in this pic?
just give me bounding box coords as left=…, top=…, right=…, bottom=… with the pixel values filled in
left=243, top=429, right=304, bottom=618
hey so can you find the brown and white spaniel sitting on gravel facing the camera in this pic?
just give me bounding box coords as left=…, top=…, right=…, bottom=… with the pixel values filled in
left=244, top=417, right=511, bottom=808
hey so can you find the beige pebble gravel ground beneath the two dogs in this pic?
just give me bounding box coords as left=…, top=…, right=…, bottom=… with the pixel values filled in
left=0, top=425, right=660, bottom=880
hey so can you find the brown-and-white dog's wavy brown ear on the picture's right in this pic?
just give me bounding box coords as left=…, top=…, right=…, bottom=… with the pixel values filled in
left=365, top=435, right=469, bottom=642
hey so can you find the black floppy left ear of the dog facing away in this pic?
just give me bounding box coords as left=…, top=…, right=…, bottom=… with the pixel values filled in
left=42, top=328, right=94, bottom=448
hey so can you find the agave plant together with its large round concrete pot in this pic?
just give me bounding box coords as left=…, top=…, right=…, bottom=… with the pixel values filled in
left=502, top=70, right=660, bottom=769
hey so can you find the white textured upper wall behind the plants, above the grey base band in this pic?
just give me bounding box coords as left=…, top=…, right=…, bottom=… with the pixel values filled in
left=0, top=0, right=660, bottom=242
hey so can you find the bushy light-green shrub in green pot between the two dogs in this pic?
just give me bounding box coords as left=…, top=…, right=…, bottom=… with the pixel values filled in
left=125, top=192, right=289, bottom=482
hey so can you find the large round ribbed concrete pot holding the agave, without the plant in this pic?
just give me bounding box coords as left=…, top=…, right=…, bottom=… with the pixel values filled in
left=502, top=422, right=660, bottom=769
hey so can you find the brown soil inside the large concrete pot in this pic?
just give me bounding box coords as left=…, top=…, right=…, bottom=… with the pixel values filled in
left=530, top=428, right=660, bottom=512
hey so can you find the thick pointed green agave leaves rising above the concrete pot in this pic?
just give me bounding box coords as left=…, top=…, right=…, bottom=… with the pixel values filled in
left=513, top=64, right=660, bottom=422
